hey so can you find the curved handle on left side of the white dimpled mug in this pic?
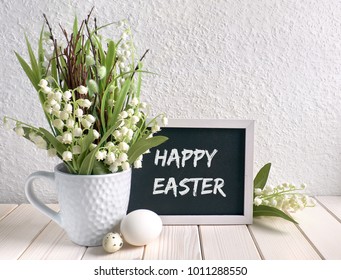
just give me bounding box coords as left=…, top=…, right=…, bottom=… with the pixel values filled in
left=25, top=171, right=62, bottom=226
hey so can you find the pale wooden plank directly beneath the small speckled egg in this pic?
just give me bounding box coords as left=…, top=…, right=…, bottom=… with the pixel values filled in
left=82, top=243, right=144, bottom=260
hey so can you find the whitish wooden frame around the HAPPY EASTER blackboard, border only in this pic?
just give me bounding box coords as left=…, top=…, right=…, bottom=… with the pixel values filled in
left=129, top=119, right=254, bottom=225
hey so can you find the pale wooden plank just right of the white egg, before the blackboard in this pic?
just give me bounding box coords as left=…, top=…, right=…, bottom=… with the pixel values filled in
left=144, top=226, right=201, bottom=260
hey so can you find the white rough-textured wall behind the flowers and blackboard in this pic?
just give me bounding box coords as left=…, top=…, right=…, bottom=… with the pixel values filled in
left=0, top=0, right=341, bottom=203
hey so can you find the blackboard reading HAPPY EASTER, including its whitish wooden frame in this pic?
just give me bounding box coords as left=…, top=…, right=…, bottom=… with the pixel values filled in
left=128, top=120, right=254, bottom=224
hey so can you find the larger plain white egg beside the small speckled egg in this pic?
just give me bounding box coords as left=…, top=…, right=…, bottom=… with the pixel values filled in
left=120, top=209, right=162, bottom=246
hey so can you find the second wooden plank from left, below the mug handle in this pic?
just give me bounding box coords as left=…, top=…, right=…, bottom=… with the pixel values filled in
left=0, top=204, right=50, bottom=260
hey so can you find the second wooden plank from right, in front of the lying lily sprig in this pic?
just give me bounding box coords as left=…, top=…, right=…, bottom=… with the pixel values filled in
left=293, top=204, right=341, bottom=260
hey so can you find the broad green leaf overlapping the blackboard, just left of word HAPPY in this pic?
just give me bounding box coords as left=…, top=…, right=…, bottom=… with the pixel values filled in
left=128, top=136, right=168, bottom=164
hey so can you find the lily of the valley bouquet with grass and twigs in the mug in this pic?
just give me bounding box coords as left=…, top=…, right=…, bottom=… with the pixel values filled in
left=3, top=8, right=167, bottom=175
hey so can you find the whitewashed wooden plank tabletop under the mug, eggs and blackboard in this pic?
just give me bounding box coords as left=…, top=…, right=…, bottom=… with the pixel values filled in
left=0, top=196, right=341, bottom=260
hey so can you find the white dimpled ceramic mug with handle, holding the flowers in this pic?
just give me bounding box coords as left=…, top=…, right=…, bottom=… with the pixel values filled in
left=25, top=164, right=131, bottom=246
